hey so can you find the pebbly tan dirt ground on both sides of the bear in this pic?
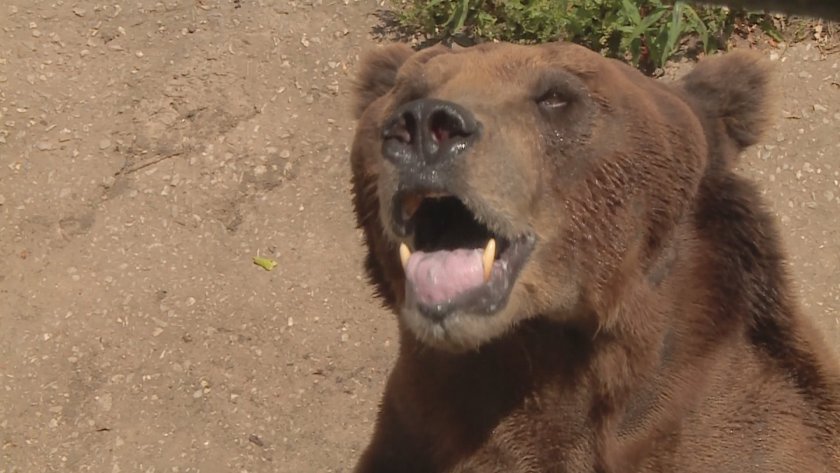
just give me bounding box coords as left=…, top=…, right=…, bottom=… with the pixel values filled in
left=0, top=0, right=840, bottom=473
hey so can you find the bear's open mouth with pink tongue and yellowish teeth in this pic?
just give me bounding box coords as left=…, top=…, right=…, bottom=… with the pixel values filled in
left=394, top=193, right=535, bottom=320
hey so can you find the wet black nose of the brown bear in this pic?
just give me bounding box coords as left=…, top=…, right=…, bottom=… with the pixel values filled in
left=382, top=99, right=480, bottom=168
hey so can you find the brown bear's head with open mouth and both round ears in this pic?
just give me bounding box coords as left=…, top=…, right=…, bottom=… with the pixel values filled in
left=351, top=43, right=768, bottom=351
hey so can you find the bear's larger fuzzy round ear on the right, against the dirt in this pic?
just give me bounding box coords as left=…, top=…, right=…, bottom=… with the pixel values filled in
left=681, top=51, right=775, bottom=149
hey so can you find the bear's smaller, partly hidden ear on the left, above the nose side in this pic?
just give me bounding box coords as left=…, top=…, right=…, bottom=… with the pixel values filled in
left=353, top=44, right=414, bottom=118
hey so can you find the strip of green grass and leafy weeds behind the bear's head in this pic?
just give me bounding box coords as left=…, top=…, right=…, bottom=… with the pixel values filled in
left=392, top=0, right=778, bottom=72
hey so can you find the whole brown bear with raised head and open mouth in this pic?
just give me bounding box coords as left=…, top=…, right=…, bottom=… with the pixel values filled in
left=351, top=43, right=840, bottom=473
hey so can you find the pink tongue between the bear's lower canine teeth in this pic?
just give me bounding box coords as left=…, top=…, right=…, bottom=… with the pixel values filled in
left=405, top=249, right=484, bottom=305
